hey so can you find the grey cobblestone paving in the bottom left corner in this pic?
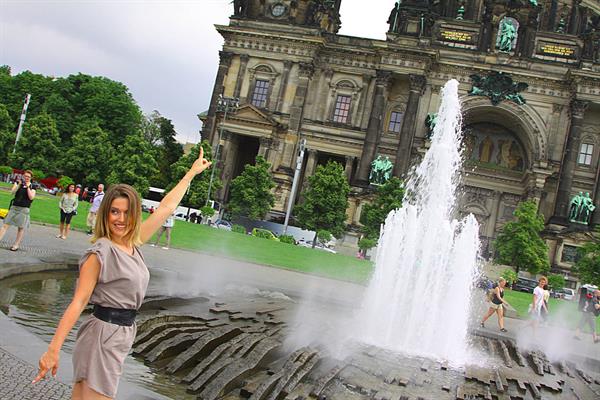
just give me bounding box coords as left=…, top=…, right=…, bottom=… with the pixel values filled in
left=0, top=349, right=71, bottom=400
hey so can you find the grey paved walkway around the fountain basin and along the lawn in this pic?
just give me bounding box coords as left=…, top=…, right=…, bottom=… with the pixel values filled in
left=0, top=225, right=600, bottom=399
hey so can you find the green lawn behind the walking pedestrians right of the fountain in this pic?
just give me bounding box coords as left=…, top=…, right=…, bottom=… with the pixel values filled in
left=504, top=290, right=600, bottom=332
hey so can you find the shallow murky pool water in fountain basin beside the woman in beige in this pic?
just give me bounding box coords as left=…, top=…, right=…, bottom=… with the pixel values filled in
left=0, top=272, right=195, bottom=399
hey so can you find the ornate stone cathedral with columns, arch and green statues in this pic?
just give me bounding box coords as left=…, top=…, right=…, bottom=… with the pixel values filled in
left=201, top=0, right=600, bottom=280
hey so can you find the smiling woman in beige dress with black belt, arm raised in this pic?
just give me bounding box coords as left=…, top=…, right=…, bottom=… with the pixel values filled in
left=33, top=148, right=211, bottom=400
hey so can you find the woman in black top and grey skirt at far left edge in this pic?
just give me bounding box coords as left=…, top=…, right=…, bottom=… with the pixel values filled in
left=0, top=170, right=35, bottom=251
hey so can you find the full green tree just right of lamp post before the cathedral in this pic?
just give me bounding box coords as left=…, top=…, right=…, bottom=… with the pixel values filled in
left=294, top=162, right=350, bottom=247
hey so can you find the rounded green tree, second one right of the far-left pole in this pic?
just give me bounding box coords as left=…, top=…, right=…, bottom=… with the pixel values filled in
left=63, top=125, right=115, bottom=186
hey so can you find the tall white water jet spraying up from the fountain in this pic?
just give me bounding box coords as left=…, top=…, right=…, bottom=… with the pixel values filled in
left=357, top=80, right=479, bottom=365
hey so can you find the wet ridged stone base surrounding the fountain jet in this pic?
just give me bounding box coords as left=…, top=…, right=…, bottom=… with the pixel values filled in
left=134, top=299, right=600, bottom=400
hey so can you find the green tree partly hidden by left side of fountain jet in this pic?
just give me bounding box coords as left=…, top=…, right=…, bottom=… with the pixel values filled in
left=360, top=177, right=404, bottom=241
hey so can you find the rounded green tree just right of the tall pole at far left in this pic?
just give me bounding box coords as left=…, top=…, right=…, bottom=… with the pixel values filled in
left=9, top=113, right=60, bottom=174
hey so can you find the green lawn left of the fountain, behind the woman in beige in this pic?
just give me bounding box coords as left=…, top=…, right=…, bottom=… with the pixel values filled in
left=0, top=184, right=372, bottom=283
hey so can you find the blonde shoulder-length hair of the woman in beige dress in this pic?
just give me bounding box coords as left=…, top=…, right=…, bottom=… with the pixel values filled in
left=92, top=183, right=142, bottom=246
